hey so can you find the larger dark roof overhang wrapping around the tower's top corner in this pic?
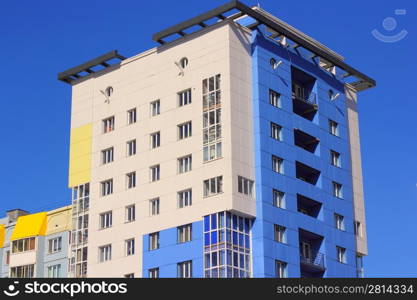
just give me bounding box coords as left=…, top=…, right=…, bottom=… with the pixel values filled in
left=153, top=0, right=376, bottom=91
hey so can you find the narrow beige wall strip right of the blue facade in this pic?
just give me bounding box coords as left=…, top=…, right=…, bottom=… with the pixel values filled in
left=346, top=86, right=368, bottom=255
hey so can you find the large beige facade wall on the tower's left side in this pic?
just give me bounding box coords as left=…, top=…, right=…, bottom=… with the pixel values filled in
left=71, top=22, right=255, bottom=277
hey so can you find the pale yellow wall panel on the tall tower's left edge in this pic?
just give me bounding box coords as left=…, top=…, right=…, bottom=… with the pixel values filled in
left=68, top=124, right=93, bottom=187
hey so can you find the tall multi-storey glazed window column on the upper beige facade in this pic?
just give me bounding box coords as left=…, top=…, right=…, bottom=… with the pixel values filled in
left=203, top=74, right=222, bottom=162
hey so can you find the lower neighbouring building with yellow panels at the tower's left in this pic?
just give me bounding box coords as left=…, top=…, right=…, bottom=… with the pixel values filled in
left=0, top=206, right=72, bottom=278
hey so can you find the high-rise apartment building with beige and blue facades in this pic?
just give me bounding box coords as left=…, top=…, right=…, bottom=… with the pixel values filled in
left=58, top=1, right=375, bottom=278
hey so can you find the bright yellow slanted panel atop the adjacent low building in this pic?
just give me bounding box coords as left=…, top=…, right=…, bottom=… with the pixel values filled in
left=10, top=212, right=47, bottom=241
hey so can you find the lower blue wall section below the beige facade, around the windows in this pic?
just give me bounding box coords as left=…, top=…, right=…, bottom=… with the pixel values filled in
left=142, top=221, right=204, bottom=278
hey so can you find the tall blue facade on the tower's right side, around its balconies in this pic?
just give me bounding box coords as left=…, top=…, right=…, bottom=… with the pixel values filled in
left=252, top=29, right=356, bottom=277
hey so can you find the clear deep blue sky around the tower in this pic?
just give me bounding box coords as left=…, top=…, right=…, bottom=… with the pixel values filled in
left=0, top=0, right=417, bottom=277
